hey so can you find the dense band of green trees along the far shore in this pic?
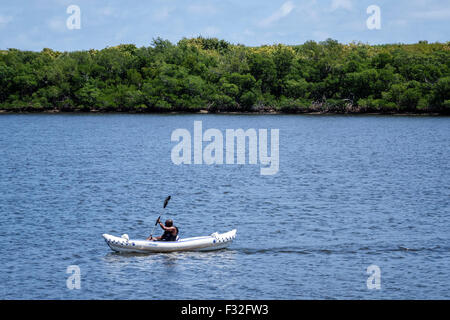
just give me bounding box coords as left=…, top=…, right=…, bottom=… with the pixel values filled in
left=0, top=37, right=450, bottom=114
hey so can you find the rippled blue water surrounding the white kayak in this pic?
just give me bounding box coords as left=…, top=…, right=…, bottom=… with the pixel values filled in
left=0, top=114, right=450, bottom=299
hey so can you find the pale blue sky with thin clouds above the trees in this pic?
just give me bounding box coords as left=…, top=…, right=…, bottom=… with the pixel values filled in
left=0, top=0, right=450, bottom=51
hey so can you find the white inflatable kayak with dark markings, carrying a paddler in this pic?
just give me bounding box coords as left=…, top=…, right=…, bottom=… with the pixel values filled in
left=103, top=229, right=237, bottom=253
